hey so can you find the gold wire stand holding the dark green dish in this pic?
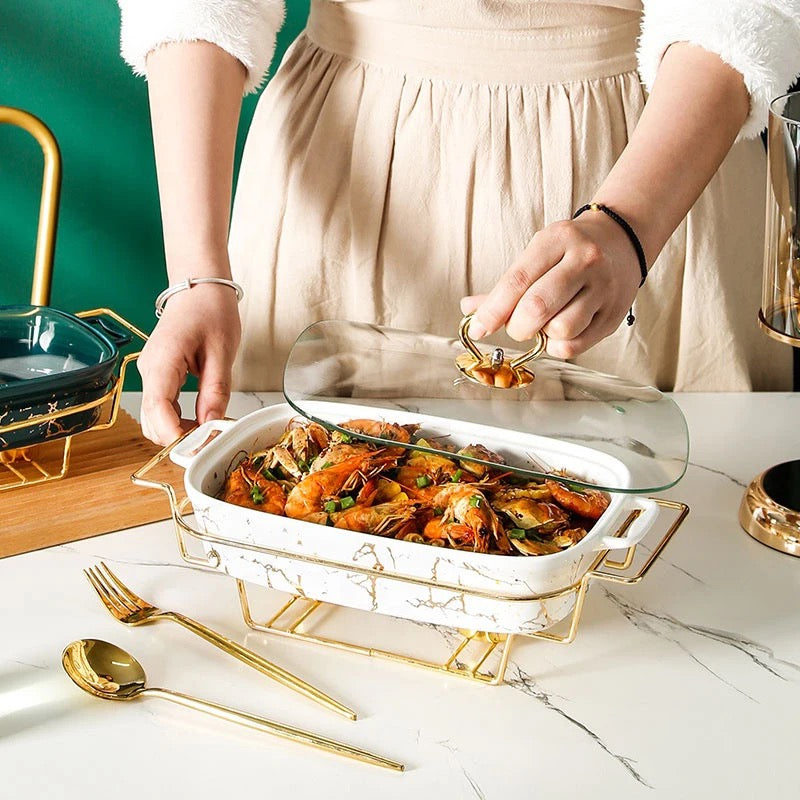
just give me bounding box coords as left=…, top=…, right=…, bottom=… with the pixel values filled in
left=0, top=308, right=147, bottom=492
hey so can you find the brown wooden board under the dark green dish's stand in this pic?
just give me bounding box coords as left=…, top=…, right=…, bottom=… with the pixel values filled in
left=0, top=410, right=183, bottom=558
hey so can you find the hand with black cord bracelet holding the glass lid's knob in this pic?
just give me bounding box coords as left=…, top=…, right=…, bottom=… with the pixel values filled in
left=461, top=211, right=641, bottom=358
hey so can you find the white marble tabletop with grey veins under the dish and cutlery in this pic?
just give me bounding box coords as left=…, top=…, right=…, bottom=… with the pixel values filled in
left=0, top=394, right=800, bottom=800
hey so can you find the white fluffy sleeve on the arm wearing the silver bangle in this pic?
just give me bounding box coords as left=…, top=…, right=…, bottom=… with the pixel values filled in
left=118, top=0, right=284, bottom=94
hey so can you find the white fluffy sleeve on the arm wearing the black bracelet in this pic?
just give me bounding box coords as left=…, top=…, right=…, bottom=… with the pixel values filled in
left=638, top=0, right=800, bottom=139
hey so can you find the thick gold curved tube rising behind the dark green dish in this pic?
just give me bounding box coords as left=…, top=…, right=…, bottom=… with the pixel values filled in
left=0, top=106, right=61, bottom=306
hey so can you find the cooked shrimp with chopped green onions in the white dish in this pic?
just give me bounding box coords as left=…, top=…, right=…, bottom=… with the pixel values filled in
left=220, top=417, right=609, bottom=556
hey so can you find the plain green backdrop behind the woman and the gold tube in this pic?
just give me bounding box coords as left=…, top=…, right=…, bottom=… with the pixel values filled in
left=0, top=0, right=308, bottom=389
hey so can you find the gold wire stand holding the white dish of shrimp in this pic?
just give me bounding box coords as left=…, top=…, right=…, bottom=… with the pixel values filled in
left=131, top=433, right=689, bottom=685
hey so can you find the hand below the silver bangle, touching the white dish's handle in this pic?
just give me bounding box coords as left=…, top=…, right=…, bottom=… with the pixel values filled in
left=138, top=283, right=241, bottom=445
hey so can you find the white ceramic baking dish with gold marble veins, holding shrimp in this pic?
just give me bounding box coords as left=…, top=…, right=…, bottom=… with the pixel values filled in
left=171, top=402, right=658, bottom=633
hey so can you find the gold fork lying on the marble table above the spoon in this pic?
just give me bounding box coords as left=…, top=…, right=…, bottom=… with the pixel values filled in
left=83, top=561, right=356, bottom=719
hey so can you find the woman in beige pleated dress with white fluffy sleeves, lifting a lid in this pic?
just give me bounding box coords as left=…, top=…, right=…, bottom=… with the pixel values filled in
left=120, top=0, right=800, bottom=443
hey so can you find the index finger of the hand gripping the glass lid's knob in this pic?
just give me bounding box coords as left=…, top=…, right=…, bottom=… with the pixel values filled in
left=469, top=223, right=566, bottom=339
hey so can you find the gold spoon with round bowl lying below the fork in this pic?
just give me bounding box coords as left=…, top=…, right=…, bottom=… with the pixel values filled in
left=61, top=639, right=404, bottom=772
